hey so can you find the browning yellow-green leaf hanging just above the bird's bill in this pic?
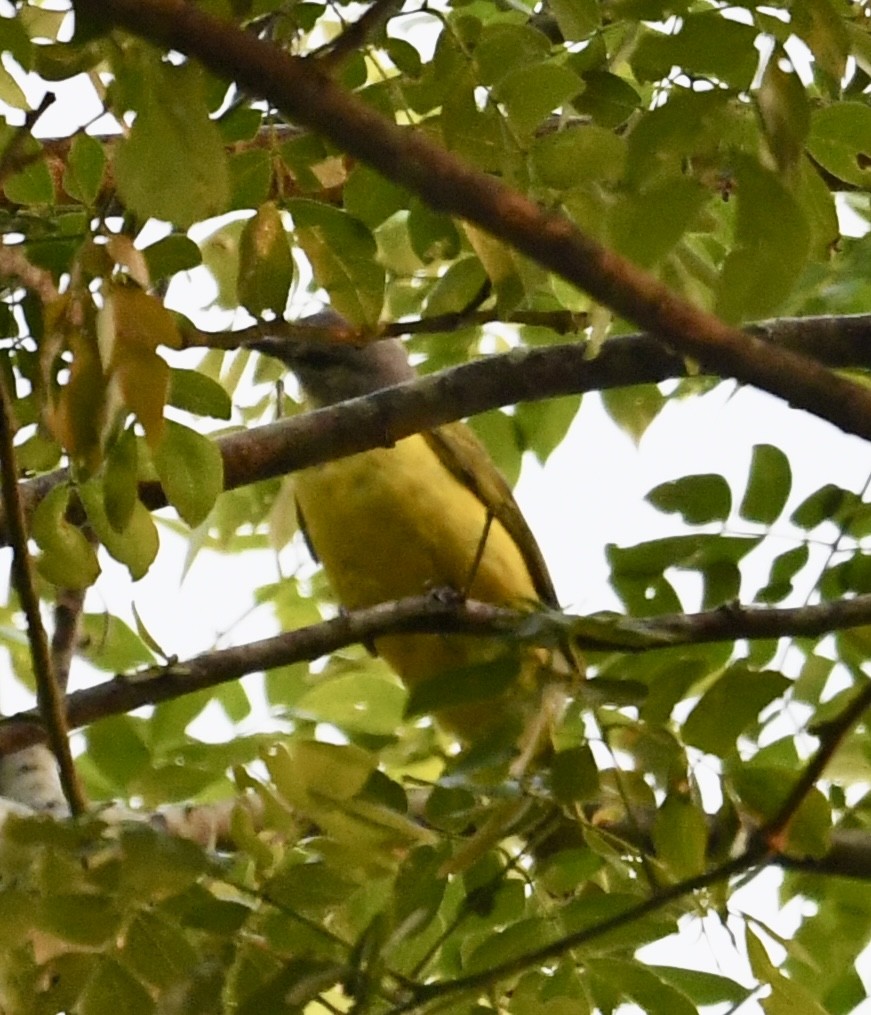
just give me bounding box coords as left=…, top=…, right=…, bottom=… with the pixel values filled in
left=236, top=201, right=293, bottom=317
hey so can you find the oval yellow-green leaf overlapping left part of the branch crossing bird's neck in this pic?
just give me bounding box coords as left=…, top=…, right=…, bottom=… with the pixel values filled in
left=153, top=419, right=223, bottom=528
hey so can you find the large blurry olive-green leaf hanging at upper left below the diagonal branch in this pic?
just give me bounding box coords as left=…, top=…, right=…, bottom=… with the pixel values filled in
left=115, top=62, right=229, bottom=228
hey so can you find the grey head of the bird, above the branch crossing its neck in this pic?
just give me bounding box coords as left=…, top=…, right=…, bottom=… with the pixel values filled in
left=253, top=311, right=415, bottom=405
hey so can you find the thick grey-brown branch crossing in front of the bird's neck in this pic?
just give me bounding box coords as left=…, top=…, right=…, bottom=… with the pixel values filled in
left=0, top=308, right=871, bottom=544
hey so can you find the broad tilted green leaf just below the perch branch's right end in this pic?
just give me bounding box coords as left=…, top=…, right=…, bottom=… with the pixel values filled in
left=682, top=664, right=790, bottom=757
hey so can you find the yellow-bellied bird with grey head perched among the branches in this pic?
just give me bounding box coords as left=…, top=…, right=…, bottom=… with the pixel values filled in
left=254, top=311, right=575, bottom=757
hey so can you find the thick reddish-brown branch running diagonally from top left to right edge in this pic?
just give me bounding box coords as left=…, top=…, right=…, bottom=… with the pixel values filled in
left=75, top=0, right=871, bottom=438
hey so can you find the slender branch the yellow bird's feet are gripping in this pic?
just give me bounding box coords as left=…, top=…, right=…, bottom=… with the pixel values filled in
left=0, top=595, right=871, bottom=754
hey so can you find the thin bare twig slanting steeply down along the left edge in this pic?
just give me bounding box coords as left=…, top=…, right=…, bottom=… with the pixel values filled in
left=0, top=378, right=85, bottom=815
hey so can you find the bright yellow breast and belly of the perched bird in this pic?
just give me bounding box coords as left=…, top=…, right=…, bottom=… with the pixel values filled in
left=296, top=434, right=536, bottom=718
